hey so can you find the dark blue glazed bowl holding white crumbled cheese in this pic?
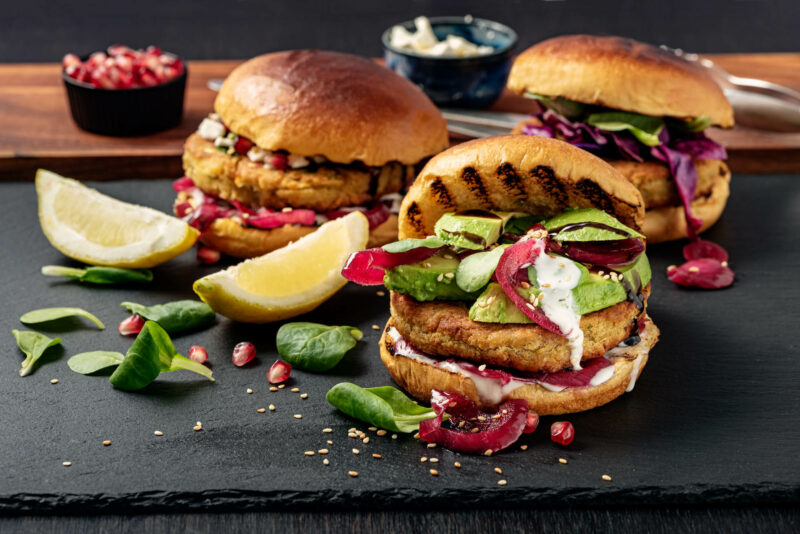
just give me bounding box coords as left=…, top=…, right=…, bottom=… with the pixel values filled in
left=381, top=17, right=517, bottom=108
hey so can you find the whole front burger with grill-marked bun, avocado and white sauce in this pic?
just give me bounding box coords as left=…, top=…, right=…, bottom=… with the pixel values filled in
left=343, top=135, right=659, bottom=415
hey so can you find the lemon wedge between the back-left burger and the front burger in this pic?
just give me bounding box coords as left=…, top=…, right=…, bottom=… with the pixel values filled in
left=193, top=211, right=369, bottom=323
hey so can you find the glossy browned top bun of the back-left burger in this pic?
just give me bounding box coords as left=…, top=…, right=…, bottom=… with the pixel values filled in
left=214, top=50, right=449, bottom=166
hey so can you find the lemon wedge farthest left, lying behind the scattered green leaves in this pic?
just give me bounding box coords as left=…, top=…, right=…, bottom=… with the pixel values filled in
left=36, top=169, right=200, bottom=269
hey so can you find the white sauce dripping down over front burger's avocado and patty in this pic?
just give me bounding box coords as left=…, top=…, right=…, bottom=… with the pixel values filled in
left=533, top=248, right=583, bottom=371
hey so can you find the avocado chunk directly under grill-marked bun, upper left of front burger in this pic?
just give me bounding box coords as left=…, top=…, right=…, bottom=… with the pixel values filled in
left=434, top=210, right=505, bottom=250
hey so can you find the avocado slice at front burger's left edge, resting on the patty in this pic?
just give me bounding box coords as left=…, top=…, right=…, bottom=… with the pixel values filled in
left=383, top=252, right=480, bottom=302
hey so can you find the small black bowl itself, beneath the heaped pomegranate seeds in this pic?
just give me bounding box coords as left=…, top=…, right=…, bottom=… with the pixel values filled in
left=61, top=53, right=188, bottom=137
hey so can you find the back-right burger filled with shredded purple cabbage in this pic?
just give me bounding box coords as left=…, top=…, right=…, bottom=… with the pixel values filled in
left=508, top=35, right=733, bottom=243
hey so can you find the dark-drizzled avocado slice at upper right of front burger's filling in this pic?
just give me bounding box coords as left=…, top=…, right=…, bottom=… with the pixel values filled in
left=544, top=208, right=644, bottom=241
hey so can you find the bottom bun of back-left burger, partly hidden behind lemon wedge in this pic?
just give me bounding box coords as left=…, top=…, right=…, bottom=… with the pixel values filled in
left=200, top=214, right=397, bottom=258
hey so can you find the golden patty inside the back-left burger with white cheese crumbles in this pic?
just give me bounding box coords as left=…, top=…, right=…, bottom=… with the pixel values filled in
left=183, top=133, right=415, bottom=212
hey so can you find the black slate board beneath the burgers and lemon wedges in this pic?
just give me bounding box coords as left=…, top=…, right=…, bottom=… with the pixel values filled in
left=0, top=176, right=800, bottom=513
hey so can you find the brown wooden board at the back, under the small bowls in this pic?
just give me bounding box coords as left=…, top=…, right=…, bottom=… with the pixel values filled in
left=0, top=53, right=800, bottom=180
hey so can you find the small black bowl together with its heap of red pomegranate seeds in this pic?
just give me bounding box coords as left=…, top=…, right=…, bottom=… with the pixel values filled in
left=62, top=45, right=187, bottom=136
